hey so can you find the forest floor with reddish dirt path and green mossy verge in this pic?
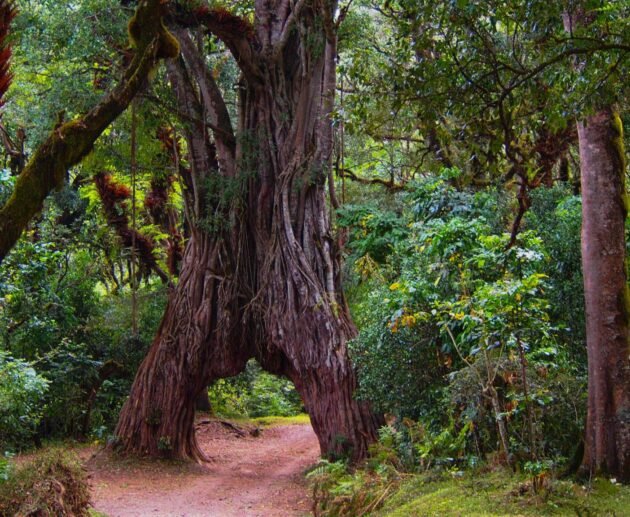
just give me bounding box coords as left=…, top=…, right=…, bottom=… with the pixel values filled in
left=6, top=416, right=630, bottom=517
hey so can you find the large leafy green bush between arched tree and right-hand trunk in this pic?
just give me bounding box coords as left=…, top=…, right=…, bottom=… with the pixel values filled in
left=349, top=178, right=586, bottom=464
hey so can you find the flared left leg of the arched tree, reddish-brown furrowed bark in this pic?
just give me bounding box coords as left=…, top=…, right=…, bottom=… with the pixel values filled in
left=116, top=234, right=252, bottom=460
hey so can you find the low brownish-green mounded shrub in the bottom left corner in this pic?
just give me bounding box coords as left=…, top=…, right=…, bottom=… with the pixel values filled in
left=0, top=449, right=90, bottom=517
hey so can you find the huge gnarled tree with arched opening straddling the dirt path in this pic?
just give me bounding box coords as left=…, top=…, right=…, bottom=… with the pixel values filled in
left=116, top=0, right=378, bottom=459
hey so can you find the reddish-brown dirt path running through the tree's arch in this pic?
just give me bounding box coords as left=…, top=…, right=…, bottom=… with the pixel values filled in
left=87, top=421, right=319, bottom=517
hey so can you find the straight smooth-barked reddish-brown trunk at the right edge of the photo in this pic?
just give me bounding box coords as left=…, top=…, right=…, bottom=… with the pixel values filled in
left=578, top=109, right=630, bottom=482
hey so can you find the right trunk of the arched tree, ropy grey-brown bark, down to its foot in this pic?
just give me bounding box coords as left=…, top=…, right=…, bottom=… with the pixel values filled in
left=241, top=12, right=378, bottom=460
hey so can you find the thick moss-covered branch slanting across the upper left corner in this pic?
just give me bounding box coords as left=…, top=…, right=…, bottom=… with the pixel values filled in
left=0, top=0, right=179, bottom=262
